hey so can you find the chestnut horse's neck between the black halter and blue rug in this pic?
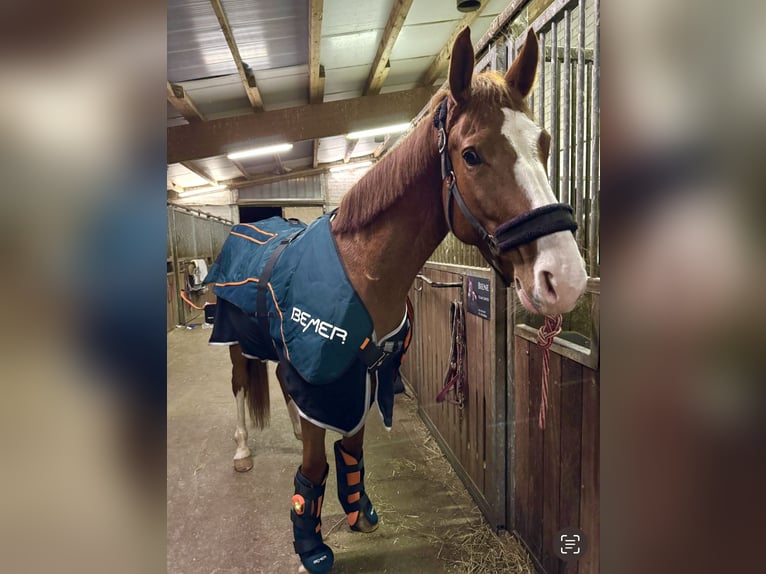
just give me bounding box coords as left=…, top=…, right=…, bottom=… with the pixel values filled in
left=336, top=125, right=447, bottom=336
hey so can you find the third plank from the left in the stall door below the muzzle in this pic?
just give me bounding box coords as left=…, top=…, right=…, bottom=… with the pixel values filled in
left=541, top=353, right=562, bottom=574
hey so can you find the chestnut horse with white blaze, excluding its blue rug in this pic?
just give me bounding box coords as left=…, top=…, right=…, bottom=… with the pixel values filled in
left=216, top=29, right=586, bottom=573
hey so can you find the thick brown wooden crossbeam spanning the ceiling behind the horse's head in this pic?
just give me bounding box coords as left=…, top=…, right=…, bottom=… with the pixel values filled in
left=167, top=87, right=435, bottom=163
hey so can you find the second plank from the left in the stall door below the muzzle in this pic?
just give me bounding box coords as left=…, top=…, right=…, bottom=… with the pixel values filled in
left=526, top=345, right=544, bottom=560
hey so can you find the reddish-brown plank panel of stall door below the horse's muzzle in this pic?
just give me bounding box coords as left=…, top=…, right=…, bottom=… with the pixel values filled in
left=513, top=336, right=600, bottom=574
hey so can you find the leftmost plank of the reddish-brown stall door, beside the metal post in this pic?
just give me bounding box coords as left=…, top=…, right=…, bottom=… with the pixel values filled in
left=513, top=337, right=530, bottom=540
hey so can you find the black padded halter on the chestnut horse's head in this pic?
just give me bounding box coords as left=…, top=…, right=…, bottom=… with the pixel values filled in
left=434, top=98, right=577, bottom=287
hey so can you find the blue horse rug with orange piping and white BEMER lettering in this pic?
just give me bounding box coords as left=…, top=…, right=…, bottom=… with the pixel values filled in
left=204, top=214, right=411, bottom=434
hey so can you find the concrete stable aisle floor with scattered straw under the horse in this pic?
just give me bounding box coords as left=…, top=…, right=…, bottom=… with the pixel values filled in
left=167, top=325, right=533, bottom=574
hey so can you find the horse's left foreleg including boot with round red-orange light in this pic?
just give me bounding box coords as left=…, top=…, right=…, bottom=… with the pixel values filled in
left=290, top=418, right=335, bottom=574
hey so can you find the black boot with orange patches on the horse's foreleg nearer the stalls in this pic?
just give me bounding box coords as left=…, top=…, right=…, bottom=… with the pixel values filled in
left=335, top=441, right=378, bottom=532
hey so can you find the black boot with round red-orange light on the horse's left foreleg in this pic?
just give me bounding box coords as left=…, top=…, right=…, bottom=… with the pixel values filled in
left=290, top=465, right=335, bottom=574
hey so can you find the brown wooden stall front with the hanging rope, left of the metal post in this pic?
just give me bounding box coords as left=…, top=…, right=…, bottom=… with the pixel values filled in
left=403, top=262, right=506, bottom=528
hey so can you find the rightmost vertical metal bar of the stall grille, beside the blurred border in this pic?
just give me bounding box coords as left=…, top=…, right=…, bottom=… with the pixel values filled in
left=588, top=0, right=601, bottom=275
